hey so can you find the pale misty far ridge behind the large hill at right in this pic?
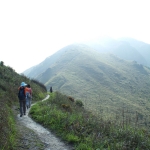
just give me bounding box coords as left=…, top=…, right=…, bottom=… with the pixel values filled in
left=84, top=37, right=150, bottom=67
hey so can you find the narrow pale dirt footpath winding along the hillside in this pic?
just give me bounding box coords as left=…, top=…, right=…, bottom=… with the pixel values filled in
left=16, top=95, right=73, bottom=150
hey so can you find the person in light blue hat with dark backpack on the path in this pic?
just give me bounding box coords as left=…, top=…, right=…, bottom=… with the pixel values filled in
left=18, top=82, right=27, bottom=117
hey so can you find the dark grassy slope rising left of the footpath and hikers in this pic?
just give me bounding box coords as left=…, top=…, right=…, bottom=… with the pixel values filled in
left=0, top=62, right=47, bottom=150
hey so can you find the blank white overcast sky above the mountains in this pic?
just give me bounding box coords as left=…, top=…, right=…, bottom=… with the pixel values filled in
left=0, top=0, right=150, bottom=73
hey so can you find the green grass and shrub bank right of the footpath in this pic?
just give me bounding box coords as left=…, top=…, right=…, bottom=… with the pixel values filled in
left=30, top=92, right=150, bottom=150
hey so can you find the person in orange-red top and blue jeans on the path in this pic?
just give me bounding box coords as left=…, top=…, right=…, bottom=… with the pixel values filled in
left=25, top=84, right=32, bottom=109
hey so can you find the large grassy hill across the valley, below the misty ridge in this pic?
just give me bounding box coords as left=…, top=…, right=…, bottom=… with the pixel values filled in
left=23, top=45, right=150, bottom=124
